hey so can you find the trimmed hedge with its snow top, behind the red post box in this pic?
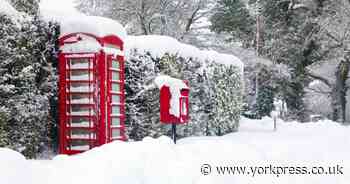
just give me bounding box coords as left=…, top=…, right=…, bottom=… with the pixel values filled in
left=125, top=36, right=243, bottom=140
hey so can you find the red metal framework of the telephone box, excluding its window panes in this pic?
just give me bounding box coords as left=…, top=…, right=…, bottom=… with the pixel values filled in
left=59, top=33, right=126, bottom=154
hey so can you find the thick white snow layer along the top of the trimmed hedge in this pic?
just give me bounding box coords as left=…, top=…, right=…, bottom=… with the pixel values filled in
left=125, top=35, right=243, bottom=70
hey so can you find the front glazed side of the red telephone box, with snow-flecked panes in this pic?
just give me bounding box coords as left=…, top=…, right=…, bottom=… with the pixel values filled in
left=60, top=54, right=99, bottom=154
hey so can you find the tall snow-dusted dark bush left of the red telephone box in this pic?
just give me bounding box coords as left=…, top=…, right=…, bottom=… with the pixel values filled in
left=0, top=1, right=57, bottom=158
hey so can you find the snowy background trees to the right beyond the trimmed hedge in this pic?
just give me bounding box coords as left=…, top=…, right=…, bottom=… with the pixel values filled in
left=210, top=0, right=350, bottom=123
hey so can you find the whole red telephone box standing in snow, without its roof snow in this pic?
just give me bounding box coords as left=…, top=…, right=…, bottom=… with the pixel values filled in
left=59, top=32, right=126, bottom=154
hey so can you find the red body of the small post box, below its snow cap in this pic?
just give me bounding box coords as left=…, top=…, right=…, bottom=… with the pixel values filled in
left=160, top=79, right=189, bottom=124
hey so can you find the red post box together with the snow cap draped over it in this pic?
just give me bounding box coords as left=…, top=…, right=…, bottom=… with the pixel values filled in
left=154, top=75, right=189, bottom=123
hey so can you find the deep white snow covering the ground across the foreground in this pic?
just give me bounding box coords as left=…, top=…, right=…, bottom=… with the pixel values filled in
left=0, top=118, right=350, bottom=184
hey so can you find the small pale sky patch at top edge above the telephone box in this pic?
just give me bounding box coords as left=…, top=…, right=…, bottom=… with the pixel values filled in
left=40, top=0, right=76, bottom=11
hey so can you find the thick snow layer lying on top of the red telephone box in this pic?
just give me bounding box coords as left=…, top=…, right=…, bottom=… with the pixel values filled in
left=41, top=8, right=126, bottom=40
